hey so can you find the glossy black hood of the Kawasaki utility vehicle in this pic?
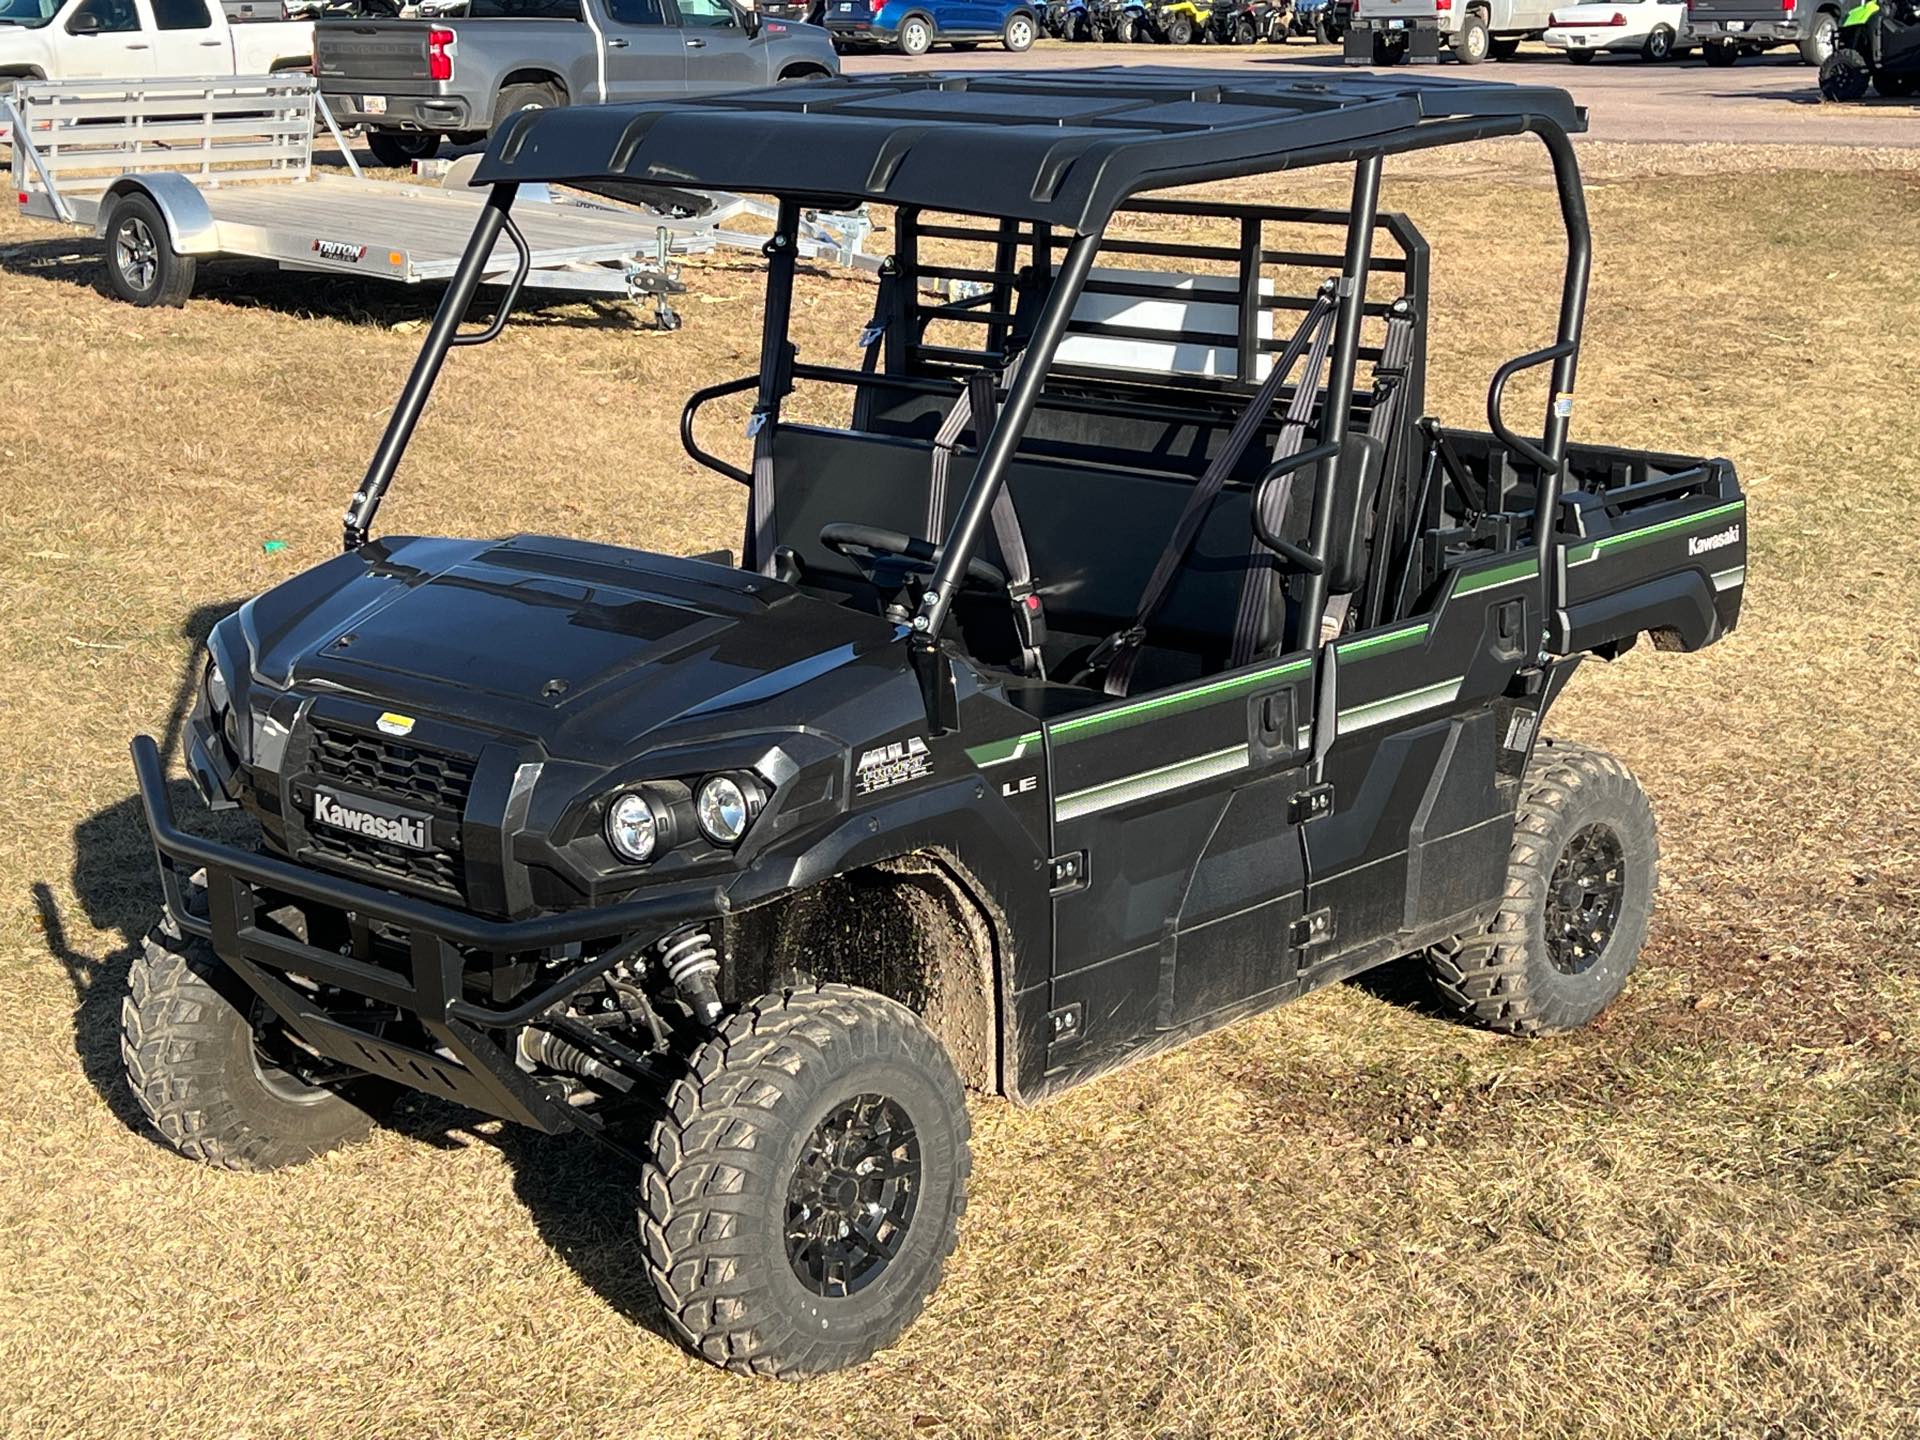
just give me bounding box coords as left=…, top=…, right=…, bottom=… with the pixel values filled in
left=242, top=536, right=904, bottom=762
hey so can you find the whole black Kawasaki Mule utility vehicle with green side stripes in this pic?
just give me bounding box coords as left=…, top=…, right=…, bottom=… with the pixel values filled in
left=125, top=69, right=1747, bottom=1375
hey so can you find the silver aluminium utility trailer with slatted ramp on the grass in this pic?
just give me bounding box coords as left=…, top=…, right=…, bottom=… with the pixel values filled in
left=0, top=75, right=864, bottom=318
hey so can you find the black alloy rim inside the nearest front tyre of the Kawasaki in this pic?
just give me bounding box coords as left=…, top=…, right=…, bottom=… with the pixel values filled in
left=787, top=1094, right=920, bottom=1296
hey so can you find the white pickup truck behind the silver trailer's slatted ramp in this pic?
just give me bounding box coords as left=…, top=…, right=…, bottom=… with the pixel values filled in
left=0, top=0, right=313, bottom=88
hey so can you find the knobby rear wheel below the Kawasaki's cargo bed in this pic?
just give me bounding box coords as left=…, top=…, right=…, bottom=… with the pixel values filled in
left=1427, top=741, right=1659, bottom=1035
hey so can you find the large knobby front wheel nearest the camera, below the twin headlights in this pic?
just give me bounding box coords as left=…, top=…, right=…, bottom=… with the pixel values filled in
left=639, top=985, right=972, bottom=1377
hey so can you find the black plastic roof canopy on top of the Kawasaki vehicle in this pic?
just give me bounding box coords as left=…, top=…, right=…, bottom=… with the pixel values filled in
left=474, top=65, right=1586, bottom=234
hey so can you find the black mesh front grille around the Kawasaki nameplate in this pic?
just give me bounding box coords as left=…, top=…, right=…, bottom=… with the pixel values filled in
left=305, top=722, right=474, bottom=900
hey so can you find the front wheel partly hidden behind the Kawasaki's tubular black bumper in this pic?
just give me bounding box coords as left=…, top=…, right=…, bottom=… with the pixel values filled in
left=121, top=918, right=388, bottom=1169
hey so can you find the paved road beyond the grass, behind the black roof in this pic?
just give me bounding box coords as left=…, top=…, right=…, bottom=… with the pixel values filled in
left=847, top=40, right=1920, bottom=146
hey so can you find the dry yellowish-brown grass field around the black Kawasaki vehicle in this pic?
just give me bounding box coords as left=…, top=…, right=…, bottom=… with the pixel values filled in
left=0, top=148, right=1920, bottom=1440
